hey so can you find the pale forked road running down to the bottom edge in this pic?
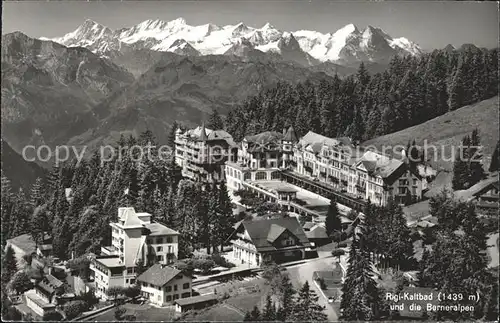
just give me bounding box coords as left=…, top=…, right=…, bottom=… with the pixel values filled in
left=287, top=251, right=338, bottom=322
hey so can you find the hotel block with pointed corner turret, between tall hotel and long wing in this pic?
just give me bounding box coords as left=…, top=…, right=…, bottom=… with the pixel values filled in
left=225, top=127, right=297, bottom=191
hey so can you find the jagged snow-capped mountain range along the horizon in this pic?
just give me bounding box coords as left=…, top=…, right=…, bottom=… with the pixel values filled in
left=42, top=18, right=422, bottom=66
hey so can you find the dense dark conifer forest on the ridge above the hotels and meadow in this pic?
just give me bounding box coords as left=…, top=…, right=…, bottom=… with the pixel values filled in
left=225, top=47, right=498, bottom=142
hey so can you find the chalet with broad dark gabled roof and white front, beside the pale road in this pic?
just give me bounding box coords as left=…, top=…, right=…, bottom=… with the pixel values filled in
left=228, top=217, right=312, bottom=266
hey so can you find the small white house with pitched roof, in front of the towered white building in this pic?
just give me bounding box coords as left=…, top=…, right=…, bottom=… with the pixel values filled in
left=137, top=264, right=193, bottom=306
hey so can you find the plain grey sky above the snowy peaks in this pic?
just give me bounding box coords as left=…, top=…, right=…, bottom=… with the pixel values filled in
left=2, top=0, right=499, bottom=49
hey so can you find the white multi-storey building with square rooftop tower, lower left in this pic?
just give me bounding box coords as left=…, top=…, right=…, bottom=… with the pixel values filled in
left=90, top=207, right=179, bottom=299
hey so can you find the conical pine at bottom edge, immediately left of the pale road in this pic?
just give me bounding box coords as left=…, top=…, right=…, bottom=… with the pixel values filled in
left=293, top=281, right=327, bottom=322
